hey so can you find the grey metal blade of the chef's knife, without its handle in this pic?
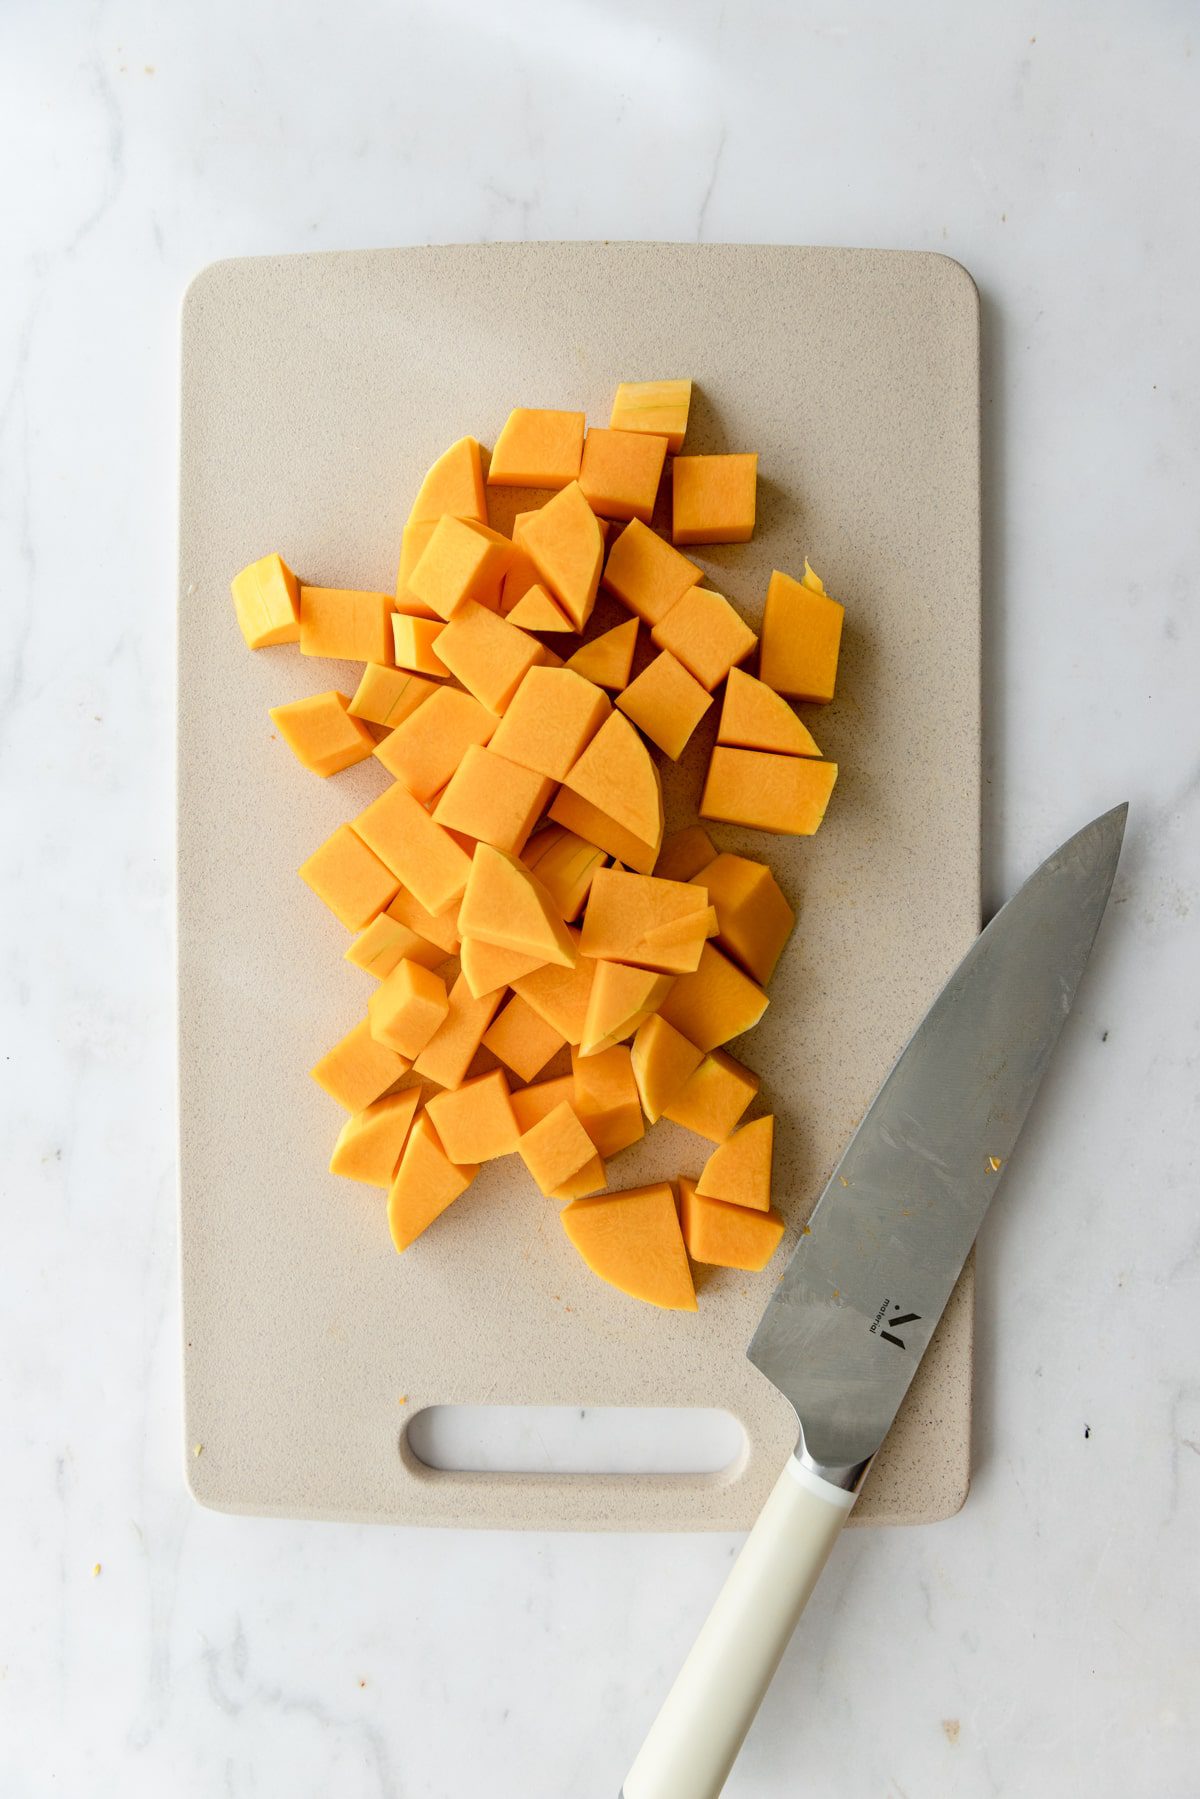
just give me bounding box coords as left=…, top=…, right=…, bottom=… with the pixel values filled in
left=747, top=806, right=1128, bottom=1482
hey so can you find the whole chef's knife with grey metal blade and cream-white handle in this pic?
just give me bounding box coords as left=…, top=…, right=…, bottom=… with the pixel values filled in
left=621, top=806, right=1128, bottom=1799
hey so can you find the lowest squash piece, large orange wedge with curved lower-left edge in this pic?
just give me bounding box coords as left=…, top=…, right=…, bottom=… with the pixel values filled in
left=560, top=1182, right=696, bottom=1311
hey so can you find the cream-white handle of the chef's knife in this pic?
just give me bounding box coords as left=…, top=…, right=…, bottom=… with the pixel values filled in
left=621, top=1455, right=858, bottom=1799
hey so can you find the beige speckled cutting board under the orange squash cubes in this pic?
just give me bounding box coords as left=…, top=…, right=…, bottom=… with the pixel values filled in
left=178, top=243, right=979, bottom=1529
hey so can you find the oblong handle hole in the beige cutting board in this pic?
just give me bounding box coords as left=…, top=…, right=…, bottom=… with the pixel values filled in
left=401, top=1405, right=747, bottom=1477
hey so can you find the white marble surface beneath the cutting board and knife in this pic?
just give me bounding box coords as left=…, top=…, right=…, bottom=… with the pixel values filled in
left=0, top=0, right=1200, bottom=1799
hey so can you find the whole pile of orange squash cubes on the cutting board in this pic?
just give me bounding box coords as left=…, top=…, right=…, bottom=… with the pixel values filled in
left=232, top=381, right=842, bottom=1310
